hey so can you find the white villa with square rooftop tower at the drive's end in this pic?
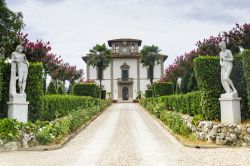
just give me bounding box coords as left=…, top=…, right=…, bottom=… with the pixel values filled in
left=82, top=38, right=167, bottom=101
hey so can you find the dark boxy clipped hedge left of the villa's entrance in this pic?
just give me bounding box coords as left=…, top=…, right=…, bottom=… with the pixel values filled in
left=73, top=83, right=97, bottom=97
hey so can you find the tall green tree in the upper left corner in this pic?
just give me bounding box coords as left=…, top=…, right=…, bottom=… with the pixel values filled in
left=0, top=0, right=24, bottom=58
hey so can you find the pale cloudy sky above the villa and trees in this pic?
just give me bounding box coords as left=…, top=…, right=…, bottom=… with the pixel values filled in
left=6, top=0, right=250, bottom=74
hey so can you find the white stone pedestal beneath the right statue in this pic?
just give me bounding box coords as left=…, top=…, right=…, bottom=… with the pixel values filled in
left=219, top=94, right=241, bottom=124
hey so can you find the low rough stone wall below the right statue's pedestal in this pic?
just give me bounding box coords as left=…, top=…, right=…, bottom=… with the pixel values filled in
left=181, top=115, right=250, bottom=146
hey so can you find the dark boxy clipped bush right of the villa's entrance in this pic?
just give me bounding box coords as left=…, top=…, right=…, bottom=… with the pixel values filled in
left=153, top=82, right=174, bottom=96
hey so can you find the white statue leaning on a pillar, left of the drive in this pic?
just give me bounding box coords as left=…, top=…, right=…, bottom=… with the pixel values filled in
left=7, top=45, right=29, bottom=97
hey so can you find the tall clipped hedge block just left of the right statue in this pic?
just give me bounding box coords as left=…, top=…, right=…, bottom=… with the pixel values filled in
left=194, top=56, right=223, bottom=120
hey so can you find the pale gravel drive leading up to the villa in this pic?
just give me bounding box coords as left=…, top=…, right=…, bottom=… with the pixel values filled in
left=0, top=103, right=250, bottom=166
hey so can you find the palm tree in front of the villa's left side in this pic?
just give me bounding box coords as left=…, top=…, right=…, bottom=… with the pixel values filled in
left=87, top=43, right=111, bottom=95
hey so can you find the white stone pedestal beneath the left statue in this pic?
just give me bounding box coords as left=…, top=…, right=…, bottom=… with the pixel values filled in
left=7, top=94, right=29, bottom=122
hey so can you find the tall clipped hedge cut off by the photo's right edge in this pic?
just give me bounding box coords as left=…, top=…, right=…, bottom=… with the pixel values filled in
left=242, top=49, right=250, bottom=112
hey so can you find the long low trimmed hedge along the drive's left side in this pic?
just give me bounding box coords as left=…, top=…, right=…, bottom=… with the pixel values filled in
left=38, top=95, right=106, bottom=120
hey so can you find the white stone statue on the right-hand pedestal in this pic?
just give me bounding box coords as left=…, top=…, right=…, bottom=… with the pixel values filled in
left=219, top=41, right=237, bottom=97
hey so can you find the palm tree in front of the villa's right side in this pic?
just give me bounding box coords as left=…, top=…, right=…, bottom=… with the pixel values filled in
left=141, top=45, right=161, bottom=85
